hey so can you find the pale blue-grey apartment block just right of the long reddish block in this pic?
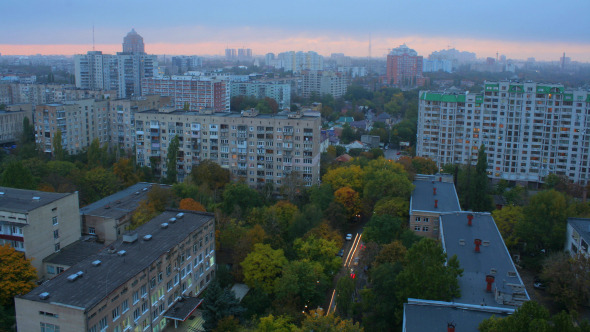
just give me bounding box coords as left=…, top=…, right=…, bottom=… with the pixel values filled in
left=230, top=81, right=291, bottom=109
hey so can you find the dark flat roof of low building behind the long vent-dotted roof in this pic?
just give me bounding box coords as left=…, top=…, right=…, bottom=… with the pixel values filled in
left=80, top=182, right=153, bottom=219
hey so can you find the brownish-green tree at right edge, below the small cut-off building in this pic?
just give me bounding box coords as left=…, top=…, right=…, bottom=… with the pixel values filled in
left=542, top=252, right=590, bottom=312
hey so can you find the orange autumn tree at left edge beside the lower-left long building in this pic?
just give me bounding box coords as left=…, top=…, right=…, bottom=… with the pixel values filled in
left=0, top=244, right=37, bottom=306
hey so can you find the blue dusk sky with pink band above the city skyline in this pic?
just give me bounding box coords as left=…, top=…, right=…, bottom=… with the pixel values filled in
left=0, top=0, right=590, bottom=62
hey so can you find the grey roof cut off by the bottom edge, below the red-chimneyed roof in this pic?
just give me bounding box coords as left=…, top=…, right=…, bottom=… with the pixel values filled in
left=403, top=299, right=507, bottom=332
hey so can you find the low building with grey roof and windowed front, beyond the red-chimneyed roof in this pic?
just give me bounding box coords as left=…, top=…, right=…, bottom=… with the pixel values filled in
left=409, top=174, right=461, bottom=239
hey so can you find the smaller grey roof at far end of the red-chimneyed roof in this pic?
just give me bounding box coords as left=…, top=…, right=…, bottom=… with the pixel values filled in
left=410, top=175, right=461, bottom=213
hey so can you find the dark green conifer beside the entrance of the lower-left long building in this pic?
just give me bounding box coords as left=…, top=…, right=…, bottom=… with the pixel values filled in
left=201, top=281, right=244, bottom=330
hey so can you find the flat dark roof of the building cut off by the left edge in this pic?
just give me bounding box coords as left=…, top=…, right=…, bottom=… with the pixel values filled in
left=0, top=187, right=73, bottom=213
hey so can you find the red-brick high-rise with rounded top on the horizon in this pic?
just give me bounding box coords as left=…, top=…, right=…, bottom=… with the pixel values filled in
left=387, top=44, right=425, bottom=86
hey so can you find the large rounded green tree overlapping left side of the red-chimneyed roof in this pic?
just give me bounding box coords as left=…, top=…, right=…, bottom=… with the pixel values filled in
left=396, top=238, right=463, bottom=301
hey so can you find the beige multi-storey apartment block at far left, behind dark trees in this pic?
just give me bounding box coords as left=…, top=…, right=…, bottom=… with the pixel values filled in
left=34, top=99, right=110, bottom=154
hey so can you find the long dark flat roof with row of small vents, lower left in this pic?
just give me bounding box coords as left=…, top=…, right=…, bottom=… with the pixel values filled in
left=21, top=210, right=214, bottom=310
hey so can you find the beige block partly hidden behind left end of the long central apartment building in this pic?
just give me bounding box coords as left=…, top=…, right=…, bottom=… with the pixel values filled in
left=109, top=95, right=170, bottom=150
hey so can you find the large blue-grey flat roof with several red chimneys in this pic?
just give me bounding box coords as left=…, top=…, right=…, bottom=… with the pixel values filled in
left=440, top=212, right=529, bottom=308
